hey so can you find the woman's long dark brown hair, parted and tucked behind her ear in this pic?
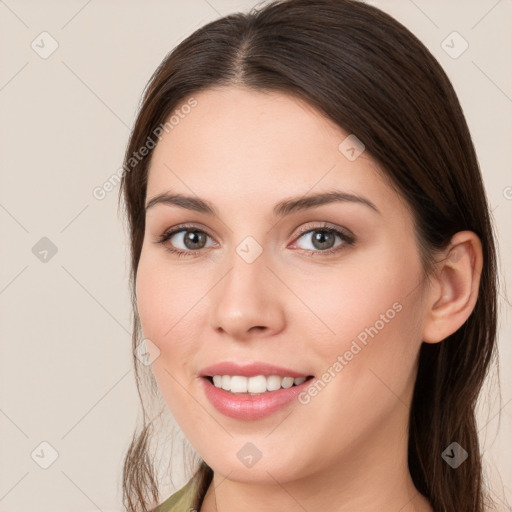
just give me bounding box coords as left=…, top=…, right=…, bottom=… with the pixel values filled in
left=120, top=0, right=498, bottom=512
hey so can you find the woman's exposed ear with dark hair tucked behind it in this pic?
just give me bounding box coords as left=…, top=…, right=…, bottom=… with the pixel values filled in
left=422, top=231, right=483, bottom=343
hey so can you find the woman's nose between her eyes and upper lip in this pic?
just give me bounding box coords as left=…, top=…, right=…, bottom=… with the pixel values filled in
left=210, top=246, right=287, bottom=341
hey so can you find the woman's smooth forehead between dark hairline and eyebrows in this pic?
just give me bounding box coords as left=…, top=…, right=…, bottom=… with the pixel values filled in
left=147, top=87, right=394, bottom=214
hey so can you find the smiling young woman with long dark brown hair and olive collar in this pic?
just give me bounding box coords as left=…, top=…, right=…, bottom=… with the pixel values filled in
left=118, top=0, right=496, bottom=512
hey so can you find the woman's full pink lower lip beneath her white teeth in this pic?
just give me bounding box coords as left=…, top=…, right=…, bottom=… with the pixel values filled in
left=202, top=377, right=314, bottom=420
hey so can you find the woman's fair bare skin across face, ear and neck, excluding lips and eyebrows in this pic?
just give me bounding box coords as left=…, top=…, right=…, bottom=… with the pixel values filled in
left=136, top=87, right=482, bottom=512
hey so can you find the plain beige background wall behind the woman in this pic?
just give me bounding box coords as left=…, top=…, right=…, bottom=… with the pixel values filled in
left=0, top=0, right=512, bottom=512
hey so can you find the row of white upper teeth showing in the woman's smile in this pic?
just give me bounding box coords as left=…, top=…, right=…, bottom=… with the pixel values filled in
left=204, top=375, right=313, bottom=396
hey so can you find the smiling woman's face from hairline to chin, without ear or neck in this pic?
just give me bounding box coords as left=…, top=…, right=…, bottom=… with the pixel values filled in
left=136, top=87, right=426, bottom=483
